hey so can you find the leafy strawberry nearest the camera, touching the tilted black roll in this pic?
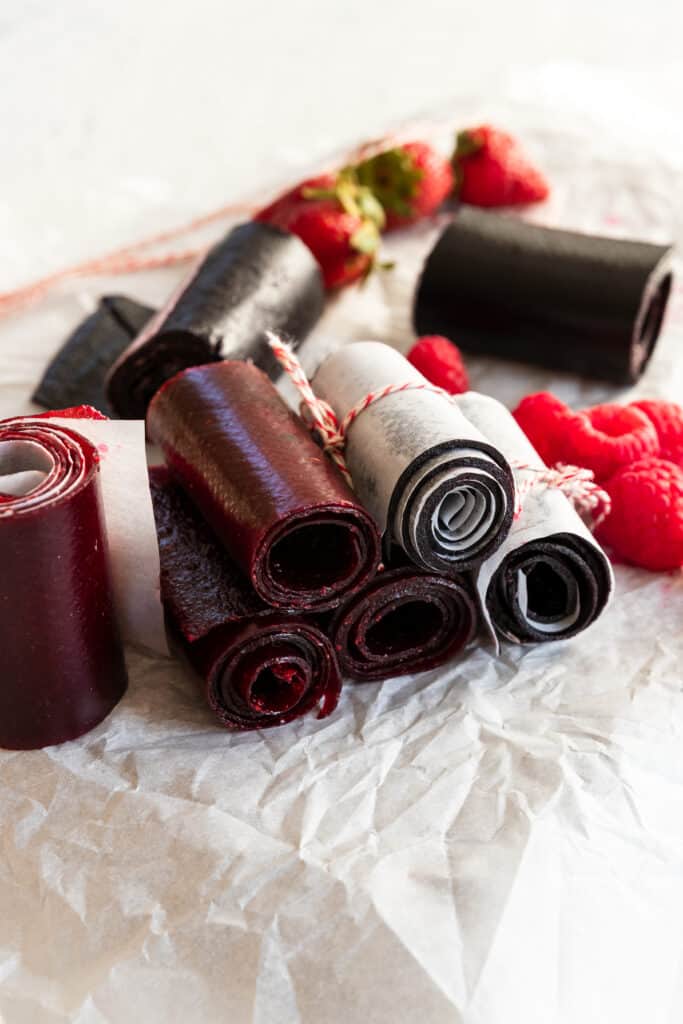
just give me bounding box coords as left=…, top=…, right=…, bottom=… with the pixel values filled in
left=255, top=168, right=385, bottom=290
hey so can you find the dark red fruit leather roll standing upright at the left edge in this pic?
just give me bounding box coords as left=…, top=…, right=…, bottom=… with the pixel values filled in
left=0, top=411, right=127, bottom=750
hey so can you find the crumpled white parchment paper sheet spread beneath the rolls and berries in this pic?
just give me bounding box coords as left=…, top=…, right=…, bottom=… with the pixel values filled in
left=0, top=76, right=683, bottom=1024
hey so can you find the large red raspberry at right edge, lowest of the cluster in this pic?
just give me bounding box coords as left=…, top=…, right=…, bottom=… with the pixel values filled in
left=597, top=456, right=683, bottom=571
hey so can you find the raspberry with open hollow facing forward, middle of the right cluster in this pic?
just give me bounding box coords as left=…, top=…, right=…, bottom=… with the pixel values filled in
left=564, top=404, right=659, bottom=481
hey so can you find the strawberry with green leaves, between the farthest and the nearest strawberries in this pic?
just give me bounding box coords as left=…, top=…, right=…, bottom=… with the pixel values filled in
left=355, top=142, right=454, bottom=228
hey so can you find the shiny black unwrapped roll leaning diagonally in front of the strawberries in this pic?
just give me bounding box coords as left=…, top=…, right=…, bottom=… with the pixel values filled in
left=108, top=221, right=325, bottom=419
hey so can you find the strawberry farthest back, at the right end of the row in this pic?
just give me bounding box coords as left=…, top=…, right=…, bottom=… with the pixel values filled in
left=453, top=125, right=550, bottom=206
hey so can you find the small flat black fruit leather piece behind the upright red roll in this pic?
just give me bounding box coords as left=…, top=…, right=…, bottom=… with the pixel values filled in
left=33, top=295, right=155, bottom=416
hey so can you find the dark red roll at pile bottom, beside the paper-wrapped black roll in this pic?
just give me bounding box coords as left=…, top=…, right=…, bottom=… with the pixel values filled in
left=327, top=565, right=479, bottom=682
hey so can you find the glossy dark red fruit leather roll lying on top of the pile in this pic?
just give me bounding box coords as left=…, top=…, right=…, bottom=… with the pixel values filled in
left=147, top=361, right=379, bottom=610
